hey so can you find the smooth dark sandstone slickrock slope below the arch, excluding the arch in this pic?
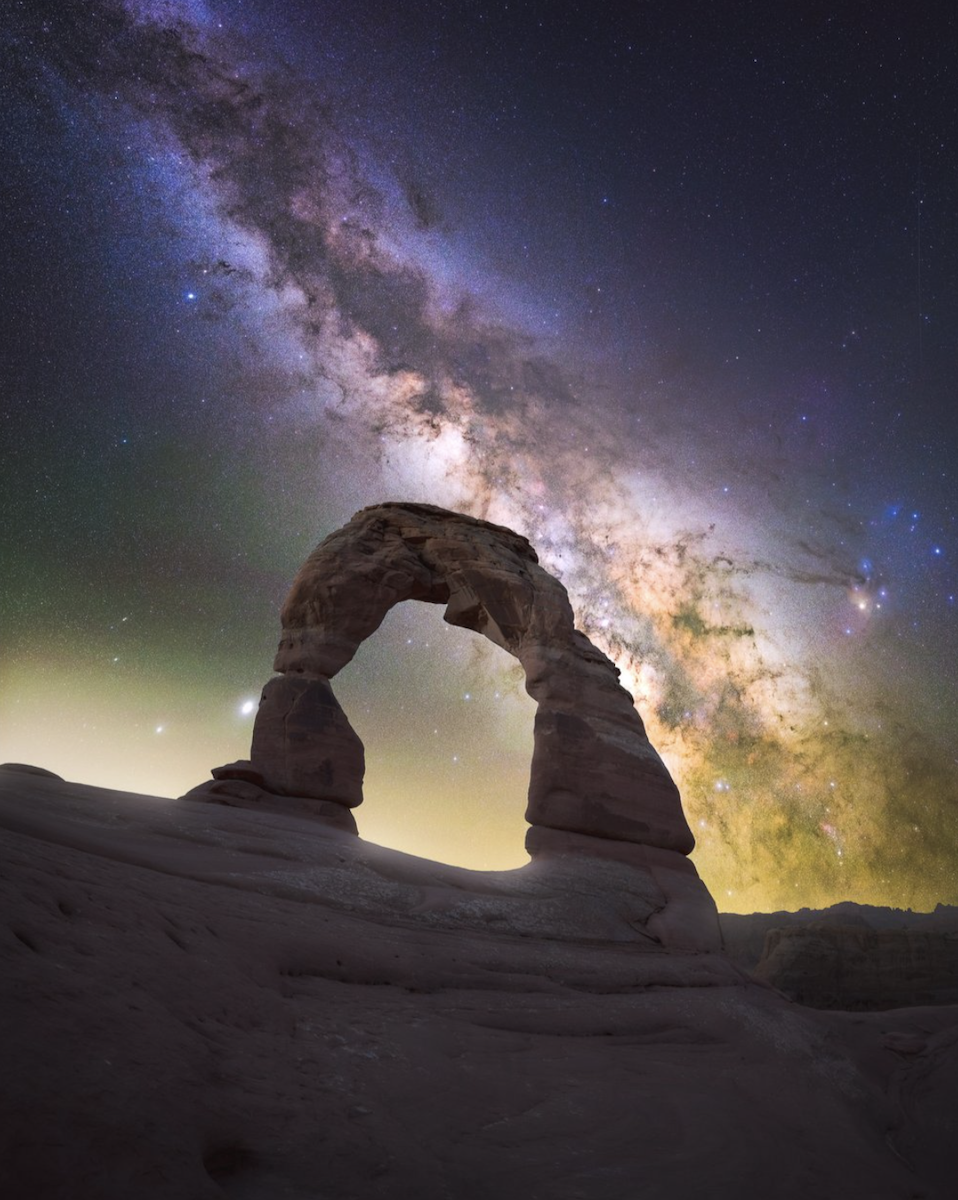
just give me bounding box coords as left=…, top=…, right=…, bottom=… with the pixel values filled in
left=0, top=770, right=958, bottom=1200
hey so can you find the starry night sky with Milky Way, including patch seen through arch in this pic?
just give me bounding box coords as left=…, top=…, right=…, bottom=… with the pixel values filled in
left=0, top=0, right=958, bottom=911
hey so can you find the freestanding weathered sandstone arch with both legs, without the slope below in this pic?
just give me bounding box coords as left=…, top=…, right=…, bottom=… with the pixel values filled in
left=187, top=503, right=720, bottom=949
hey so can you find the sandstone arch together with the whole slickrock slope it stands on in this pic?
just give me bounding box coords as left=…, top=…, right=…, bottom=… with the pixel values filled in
left=0, top=504, right=958, bottom=1200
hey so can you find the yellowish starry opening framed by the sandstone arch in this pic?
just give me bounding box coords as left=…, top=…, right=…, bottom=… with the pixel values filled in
left=334, top=601, right=535, bottom=871
